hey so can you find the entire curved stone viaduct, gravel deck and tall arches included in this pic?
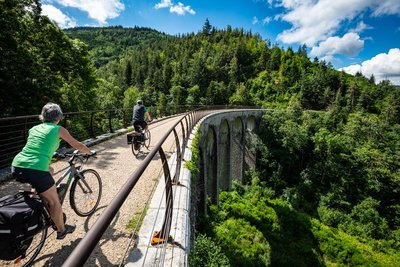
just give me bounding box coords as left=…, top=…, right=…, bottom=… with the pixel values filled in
left=0, top=109, right=263, bottom=266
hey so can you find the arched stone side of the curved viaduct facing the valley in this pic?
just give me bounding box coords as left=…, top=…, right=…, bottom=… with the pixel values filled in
left=194, top=110, right=262, bottom=208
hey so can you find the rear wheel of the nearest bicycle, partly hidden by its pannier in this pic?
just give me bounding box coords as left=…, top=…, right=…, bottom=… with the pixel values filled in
left=10, top=214, right=48, bottom=267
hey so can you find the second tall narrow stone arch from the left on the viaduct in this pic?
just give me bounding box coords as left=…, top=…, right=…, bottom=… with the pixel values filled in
left=218, top=119, right=231, bottom=191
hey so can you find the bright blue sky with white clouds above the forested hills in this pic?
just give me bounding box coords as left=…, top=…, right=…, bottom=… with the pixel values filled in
left=42, top=0, right=400, bottom=85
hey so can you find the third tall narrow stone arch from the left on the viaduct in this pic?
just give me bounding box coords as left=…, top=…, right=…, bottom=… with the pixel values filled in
left=230, top=117, right=244, bottom=183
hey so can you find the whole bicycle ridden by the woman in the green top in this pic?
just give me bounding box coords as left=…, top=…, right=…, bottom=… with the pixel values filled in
left=4, top=151, right=102, bottom=267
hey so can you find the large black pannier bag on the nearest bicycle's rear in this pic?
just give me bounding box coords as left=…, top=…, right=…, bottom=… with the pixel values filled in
left=0, top=193, right=43, bottom=260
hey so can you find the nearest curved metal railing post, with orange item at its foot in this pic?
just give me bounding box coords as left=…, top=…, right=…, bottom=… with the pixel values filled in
left=151, top=146, right=174, bottom=245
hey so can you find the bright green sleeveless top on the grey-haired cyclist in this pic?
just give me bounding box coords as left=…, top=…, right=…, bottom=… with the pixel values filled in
left=12, top=122, right=60, bottom=171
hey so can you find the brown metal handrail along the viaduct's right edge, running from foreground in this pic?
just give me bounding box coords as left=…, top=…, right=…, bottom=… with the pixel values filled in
left=62, top=109, right=211, bottom=267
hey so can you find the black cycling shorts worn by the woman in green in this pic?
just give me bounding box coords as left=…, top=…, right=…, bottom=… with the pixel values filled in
left=11, top=166, right=55, bottom=193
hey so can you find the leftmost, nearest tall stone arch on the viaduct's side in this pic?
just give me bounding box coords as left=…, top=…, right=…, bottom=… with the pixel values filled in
left=205, top=126, right=218, bottom=203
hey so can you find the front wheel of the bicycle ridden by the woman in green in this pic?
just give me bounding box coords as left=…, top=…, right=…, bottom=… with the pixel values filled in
left=69, top=169, right=102, bottom=217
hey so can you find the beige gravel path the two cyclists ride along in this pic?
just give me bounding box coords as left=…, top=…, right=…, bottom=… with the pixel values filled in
left=0, top=116, right=181, bottom=267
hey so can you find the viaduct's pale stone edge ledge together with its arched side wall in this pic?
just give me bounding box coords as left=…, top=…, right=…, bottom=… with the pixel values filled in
left=130, top=109, right=265, bottom=266
